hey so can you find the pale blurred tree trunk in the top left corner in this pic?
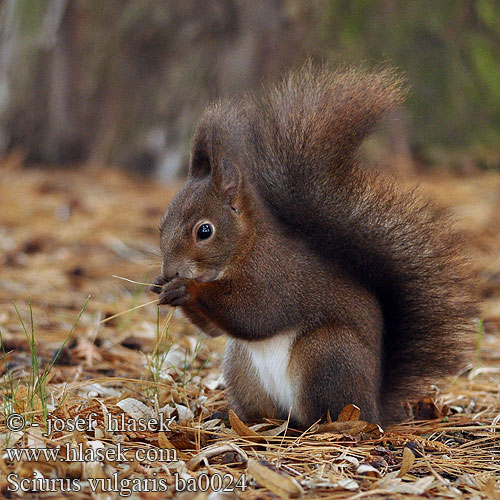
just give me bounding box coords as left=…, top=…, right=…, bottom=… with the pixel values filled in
left=0, top=0, right=71, bottom=161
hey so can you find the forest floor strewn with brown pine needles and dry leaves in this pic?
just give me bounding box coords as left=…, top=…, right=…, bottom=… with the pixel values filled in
left=0, top=156, right=500, bottom=500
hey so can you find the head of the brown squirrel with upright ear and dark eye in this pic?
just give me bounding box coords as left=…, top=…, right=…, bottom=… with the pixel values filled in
left=160, top=114, right=254, bottom=282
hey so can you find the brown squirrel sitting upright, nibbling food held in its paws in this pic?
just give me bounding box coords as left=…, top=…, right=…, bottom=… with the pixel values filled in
left=151, top=64, right=477, bottom=428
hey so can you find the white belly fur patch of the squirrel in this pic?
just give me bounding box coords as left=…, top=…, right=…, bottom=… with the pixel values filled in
left=241, top=331, right=296, bottom=412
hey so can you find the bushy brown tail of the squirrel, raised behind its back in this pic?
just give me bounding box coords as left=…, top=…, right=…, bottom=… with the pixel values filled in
left=241, top=65, right=476, bottom=422
